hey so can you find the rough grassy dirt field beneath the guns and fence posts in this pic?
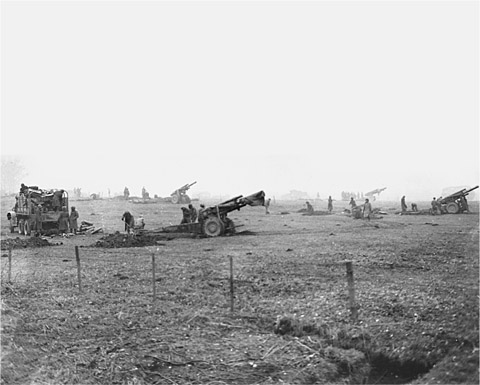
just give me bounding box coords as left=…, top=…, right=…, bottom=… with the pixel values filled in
left=1, top=198, right=479, bottom=385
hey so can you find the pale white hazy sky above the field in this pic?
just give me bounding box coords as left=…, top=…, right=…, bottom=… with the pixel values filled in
left=1, top=1, right=479, bottom=199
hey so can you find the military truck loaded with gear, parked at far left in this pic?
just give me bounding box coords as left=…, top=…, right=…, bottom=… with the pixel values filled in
left=7, top=186, right=69, bottom=235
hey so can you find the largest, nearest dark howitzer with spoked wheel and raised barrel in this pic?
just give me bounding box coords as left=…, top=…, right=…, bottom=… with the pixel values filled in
left=162, top=191, right=265, bottom=237
